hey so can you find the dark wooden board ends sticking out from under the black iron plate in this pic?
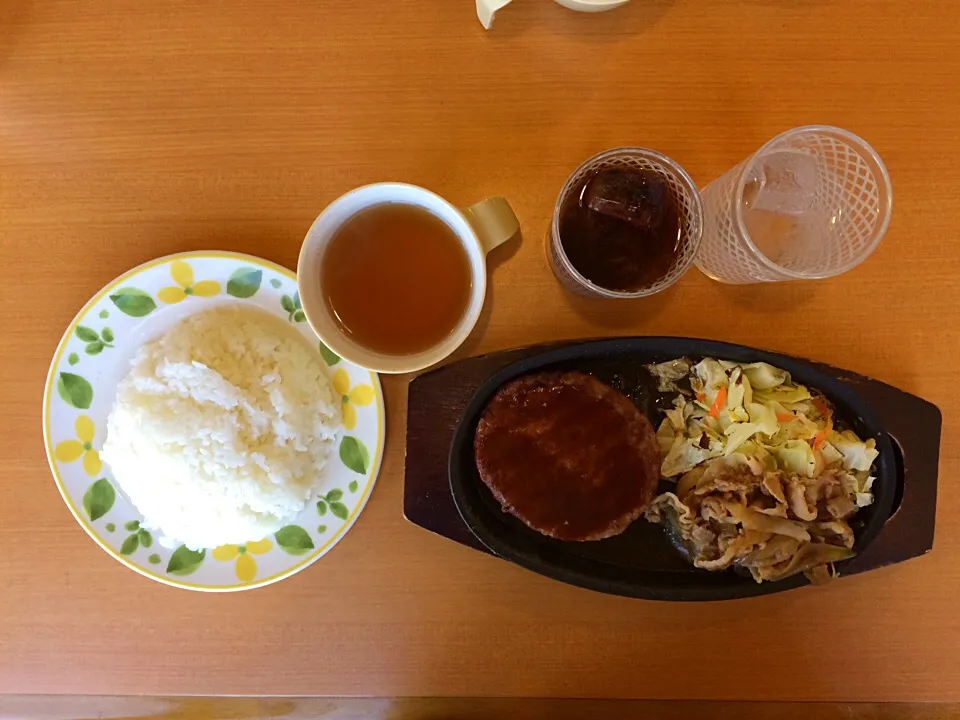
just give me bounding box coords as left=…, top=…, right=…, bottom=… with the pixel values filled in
left=403, top=340, right=941, bottom=574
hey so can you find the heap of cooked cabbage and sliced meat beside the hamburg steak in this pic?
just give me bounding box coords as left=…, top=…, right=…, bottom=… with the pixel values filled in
left=646, top=358, right=878, bottom=582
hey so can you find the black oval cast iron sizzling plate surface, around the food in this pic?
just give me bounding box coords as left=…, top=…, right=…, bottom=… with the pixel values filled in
left=448, top=337, right=902, bottom=600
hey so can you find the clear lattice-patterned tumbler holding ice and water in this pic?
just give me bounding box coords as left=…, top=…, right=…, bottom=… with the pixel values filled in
left=696, top=125, right=893, bottom=284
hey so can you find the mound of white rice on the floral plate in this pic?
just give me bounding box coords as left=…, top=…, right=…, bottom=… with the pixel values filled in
left=102, top=307, right=340, bottom=549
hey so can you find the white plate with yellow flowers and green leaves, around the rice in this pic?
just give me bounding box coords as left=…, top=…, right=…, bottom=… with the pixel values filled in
left=43, top=252, right=384, bottom=592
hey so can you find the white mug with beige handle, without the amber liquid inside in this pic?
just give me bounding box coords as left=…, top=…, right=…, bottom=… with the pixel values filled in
left=297, top=183, right=520, bottom=373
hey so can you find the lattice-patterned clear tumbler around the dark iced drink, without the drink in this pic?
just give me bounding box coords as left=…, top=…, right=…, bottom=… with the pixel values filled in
left=547, top=148, right=703, bottom=298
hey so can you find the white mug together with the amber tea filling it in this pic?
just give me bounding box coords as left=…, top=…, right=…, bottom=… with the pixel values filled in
left=297, top=182, right=520, bottom=373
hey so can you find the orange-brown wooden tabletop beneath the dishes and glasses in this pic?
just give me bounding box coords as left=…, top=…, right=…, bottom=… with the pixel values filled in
left=0, top=0, right=960, bottom=701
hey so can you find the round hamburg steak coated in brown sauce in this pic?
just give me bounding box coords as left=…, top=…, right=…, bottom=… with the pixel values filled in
left=473, top=372, right=660, bottom=541
